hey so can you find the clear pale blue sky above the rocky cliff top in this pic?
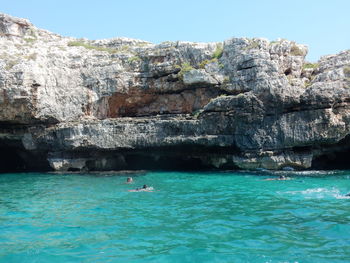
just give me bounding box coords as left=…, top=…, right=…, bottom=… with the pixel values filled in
left=0, top=0, right=350, bottom=61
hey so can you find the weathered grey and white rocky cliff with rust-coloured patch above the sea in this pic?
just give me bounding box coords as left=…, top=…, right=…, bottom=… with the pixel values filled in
left=0, top=14, right=350, bottom=171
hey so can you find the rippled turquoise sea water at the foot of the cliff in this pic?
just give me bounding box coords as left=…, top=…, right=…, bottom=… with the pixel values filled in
left=0, top=171, right=350, bottom=263
